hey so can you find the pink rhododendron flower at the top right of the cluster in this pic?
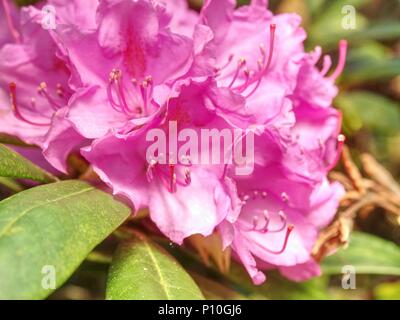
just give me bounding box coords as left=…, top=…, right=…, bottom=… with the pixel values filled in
left=201, top=0, right=305, bottom=134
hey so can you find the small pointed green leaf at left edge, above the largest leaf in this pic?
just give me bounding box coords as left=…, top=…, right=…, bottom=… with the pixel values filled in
left=0, top=144, right=57, bottom=183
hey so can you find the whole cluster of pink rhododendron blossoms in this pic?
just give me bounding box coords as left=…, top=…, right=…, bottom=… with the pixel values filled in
left=0, top=0, right=346, bottom=284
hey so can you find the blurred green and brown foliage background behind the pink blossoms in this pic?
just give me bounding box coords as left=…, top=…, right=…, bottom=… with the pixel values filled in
left=10, top=0, right=400, bottom=299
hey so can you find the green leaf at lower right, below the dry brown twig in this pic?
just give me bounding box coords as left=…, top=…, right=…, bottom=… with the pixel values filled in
left=322, top=232, right=400, bottom=275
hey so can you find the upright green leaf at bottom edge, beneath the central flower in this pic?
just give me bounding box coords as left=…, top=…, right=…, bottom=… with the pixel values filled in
left=106, top=235, right=203, bottom=300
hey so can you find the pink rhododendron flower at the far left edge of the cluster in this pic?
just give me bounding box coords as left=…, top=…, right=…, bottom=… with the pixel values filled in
left=0, top=0, right=84, bottom=171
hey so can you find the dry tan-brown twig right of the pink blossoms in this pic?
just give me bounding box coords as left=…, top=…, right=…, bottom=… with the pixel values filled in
left=313, top=146, right=400, bottom=261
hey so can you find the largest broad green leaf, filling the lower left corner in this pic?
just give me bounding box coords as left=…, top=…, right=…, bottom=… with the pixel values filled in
left=0, top=181, right=130, bottom=299
